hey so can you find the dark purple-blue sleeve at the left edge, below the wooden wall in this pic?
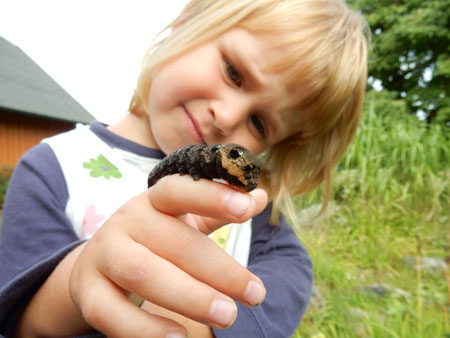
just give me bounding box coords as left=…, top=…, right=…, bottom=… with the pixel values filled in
left=0, top=144, right=80, bottom=336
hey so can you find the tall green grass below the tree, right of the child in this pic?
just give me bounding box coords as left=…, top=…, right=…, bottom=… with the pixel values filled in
left=293, top=93, right=450, bottom=338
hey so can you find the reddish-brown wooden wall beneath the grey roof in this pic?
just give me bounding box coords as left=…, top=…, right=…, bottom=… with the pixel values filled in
left=0, top=110, right=75, bottom=167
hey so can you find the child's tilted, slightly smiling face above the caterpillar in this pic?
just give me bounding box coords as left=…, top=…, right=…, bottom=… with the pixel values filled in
left=149, top=29, right=307, bottom=154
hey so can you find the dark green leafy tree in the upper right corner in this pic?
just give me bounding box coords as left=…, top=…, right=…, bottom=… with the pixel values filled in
left=353, top=0, right=450, bottom=126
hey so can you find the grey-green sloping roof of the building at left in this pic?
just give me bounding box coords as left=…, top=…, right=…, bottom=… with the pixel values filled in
left=0, top=36, right=94, bottom=123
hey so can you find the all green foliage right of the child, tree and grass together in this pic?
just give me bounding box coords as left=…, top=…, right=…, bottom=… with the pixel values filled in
left=293, top=0, right=450, bottom=338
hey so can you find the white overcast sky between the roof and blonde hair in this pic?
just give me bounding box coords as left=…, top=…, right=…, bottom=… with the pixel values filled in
left=0, top=0, right=188, bottom=124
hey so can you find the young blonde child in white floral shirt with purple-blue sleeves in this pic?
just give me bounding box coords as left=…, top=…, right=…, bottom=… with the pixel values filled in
left=0, top=0, right=367, bottom=337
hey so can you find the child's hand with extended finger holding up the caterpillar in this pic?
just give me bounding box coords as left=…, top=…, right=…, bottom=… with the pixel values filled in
left=70, top=175, right=267, bottom=337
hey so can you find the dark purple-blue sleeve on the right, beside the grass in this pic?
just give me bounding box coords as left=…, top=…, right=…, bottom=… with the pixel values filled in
left=213, top=208, right=313, bottom=338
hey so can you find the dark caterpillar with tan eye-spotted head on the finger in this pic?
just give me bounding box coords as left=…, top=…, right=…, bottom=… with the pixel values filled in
left=148, top=143, right=261, bottom=192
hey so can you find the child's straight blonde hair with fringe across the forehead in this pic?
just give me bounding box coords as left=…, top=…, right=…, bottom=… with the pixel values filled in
left=130, top=0, right=370, bottom=227
